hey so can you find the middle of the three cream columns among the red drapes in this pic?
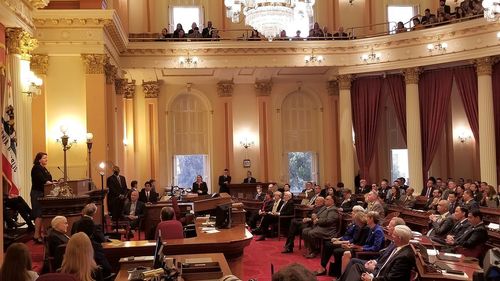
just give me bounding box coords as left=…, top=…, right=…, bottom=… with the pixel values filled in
left=404, top=68, right=424, bottom=194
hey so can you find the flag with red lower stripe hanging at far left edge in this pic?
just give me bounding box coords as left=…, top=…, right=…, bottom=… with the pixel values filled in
left=2, top=60, right=19, bottom=194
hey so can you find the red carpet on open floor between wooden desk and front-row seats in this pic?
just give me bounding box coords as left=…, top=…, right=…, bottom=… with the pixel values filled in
left=242, top=238, right=333, bottom=281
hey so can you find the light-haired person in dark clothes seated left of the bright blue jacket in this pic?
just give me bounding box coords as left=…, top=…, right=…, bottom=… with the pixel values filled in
left=314, top=206, right=369, bottom=277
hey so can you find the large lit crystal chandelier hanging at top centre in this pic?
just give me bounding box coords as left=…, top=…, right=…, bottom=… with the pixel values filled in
left=224, top=0, right=316, bottom=38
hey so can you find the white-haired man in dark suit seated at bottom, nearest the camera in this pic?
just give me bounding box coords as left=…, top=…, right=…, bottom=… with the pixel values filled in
left=339, top=225, right=415, bottom=281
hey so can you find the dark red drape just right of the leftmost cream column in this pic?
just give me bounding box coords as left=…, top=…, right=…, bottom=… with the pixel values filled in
left=351, top=77, right=382, bottom=180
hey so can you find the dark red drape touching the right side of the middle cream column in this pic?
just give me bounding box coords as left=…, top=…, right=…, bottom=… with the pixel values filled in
left=418, top=69, right=453, bottom=175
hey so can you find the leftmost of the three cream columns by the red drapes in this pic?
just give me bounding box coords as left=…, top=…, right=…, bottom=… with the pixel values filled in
left=338, top=75, right=356, bottom=191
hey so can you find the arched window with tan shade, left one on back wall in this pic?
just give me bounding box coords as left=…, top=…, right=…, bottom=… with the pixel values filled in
left=167, top=94, right=210, bottom=190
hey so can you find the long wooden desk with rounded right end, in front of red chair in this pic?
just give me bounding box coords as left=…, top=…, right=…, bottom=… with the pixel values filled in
left=103, top=218, right=253, bottom=276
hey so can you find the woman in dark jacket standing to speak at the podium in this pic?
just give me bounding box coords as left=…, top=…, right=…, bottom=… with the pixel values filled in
left=30, top=152, right=52, bottom=244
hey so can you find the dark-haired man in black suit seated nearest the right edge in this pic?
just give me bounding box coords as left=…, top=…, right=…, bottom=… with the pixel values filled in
left=443, top=209, right=488, bottom=254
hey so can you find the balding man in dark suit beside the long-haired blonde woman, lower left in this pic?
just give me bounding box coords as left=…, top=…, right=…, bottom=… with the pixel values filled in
left=47, top=216, right=69, bottom=269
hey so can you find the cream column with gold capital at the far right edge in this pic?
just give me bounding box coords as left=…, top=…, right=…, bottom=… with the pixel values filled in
left=476, top=57, right=497, bottom=186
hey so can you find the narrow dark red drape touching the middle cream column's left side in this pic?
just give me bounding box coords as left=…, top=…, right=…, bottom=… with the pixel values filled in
left=384, top=75, right=406, bottom=143
